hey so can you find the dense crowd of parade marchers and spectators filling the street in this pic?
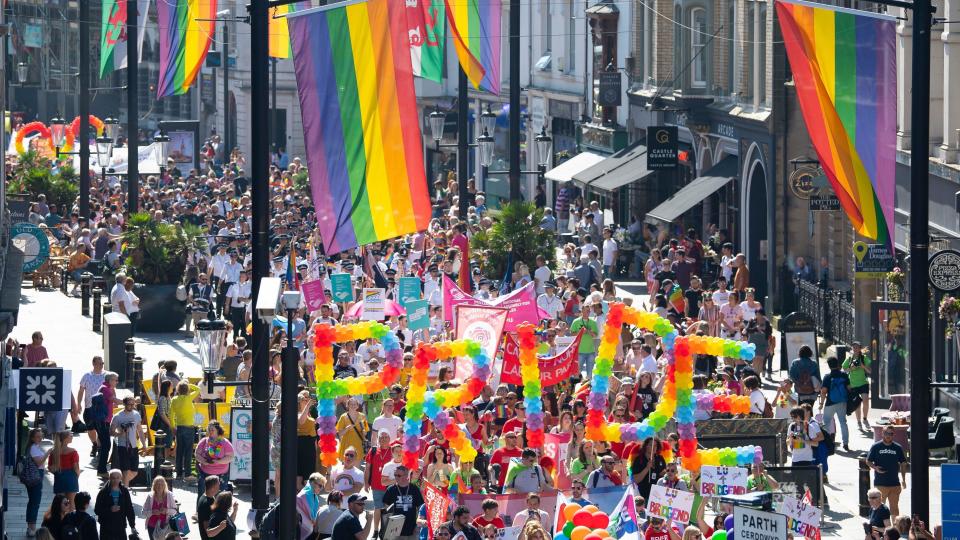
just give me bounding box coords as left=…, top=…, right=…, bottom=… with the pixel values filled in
left=8, top=135, right=928, bottom=540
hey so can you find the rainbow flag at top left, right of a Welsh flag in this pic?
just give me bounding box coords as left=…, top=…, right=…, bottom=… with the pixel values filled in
left=157, top=0, right=217, bottom=97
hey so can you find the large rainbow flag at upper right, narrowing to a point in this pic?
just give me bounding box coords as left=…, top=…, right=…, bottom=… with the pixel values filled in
left=776, top=0, right=897, bottom=245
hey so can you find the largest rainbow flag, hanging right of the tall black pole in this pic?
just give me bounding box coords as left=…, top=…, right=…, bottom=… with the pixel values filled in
left=288, top=0, right=430, bottom=253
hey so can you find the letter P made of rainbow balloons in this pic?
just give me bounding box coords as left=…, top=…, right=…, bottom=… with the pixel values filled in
left=313, top=321, right=403, bottom=467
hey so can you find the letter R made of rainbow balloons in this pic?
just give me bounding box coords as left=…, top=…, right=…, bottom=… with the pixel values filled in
left=403, top=339, right=491, bottom=468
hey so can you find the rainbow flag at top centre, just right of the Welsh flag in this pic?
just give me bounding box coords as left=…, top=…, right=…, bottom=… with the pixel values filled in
left=444, top=0, right=501, bottom=94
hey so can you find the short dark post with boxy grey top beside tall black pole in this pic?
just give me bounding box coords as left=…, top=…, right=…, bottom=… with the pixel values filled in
left=280, top=291, right=301, bottom=538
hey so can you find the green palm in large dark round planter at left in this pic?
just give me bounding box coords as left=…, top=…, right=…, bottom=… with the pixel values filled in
left=123, top=213, right=207, bottom=332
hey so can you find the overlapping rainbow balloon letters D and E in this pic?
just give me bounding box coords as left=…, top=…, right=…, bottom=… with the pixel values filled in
left=586, top=302, right=763, bottom=471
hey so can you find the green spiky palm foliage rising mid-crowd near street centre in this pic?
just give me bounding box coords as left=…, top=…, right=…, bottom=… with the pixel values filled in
left=471, top=201, right=556, bottom=279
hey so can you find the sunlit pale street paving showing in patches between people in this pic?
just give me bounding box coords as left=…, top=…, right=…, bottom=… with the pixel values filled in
left=5, top=283, right=941, bottom=539
